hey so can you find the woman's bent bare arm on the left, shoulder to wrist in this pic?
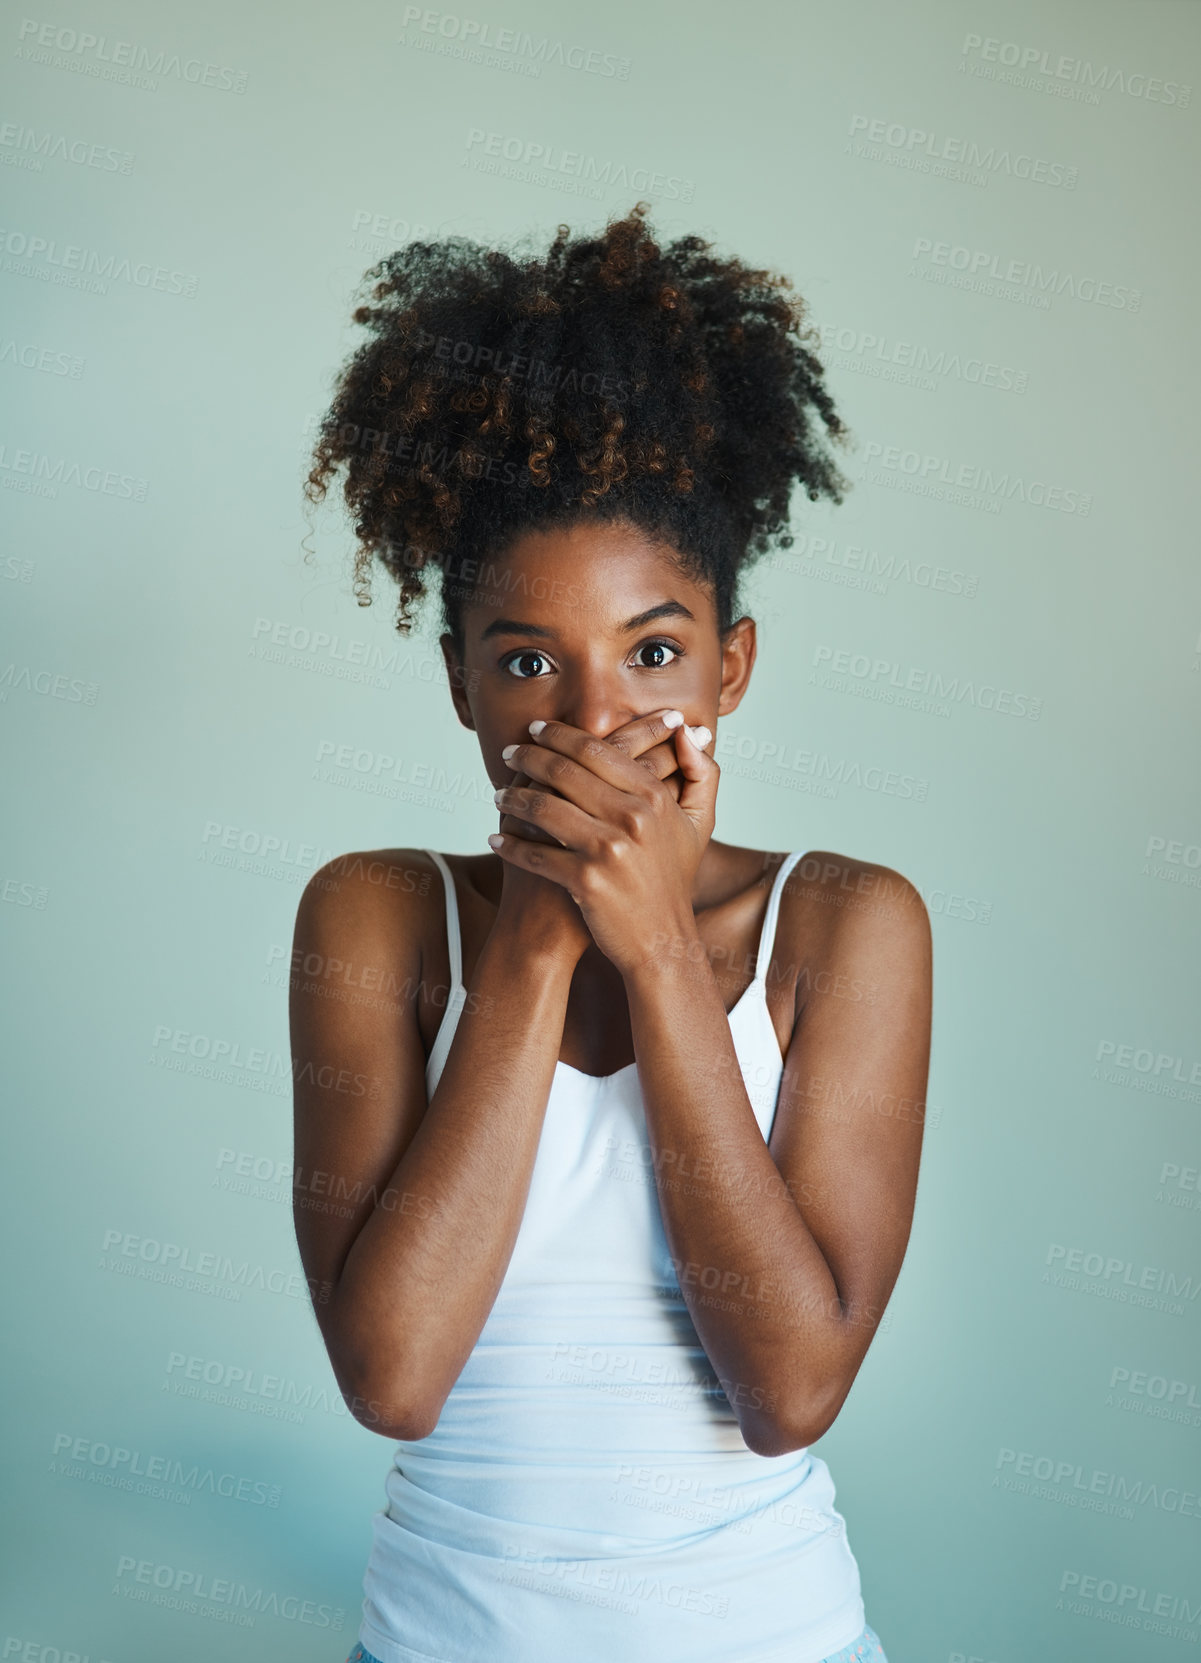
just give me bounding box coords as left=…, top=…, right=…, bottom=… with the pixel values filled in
left=291, top=850, right=579, bottom=1438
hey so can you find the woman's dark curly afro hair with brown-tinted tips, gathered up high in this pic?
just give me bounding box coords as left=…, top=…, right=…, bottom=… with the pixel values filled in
left=304, top=203, right=848, bottom=650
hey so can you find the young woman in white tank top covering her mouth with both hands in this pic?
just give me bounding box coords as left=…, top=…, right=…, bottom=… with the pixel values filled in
left=291, top=205, right=932, bottom=1663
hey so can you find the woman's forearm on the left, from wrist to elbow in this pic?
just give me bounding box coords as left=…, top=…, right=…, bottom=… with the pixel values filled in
left=329, top=928, right=574, bottom=1425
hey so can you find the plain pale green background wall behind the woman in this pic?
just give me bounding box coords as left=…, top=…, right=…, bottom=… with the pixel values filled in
left=0, top=0, right=1201, bottom=1663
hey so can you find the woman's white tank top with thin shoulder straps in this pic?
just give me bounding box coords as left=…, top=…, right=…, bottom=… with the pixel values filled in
left=359, top=850, right=865, bottom=1663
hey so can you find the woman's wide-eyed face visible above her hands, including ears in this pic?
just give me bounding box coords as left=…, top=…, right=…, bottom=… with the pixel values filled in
left=441, top=522, right=755, bottom=785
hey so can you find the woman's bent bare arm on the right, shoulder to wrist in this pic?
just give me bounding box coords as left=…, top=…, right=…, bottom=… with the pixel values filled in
left=625, top=855, right=932, bottom=1455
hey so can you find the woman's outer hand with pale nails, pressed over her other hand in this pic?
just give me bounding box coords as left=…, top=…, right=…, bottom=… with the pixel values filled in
left=489, top=717, right=722, bottom=975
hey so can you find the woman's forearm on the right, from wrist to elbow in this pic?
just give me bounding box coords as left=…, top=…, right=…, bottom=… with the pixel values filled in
left=625, top=953, right=857, bottom=1453
